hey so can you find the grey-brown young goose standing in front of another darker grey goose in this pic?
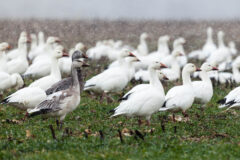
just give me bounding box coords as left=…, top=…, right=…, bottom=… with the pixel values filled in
left=28, top=52, right=88, bottom=122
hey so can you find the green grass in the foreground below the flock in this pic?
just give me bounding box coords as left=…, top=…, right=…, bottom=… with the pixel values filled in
left=0, top=78, right=240, bottom=159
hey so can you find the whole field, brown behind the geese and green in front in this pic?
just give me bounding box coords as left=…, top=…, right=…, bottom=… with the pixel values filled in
left=0, top=20, right=240, bottom=159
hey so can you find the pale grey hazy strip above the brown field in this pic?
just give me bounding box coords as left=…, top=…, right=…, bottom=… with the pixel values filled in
left=0, top=0, right=240, bottom=20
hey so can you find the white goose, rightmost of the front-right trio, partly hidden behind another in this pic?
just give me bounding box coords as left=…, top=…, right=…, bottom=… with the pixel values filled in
left=192, top=62, right=218, bottom=104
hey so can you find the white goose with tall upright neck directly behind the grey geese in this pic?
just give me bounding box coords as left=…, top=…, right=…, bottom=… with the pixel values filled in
left=29, top=46, right=68, bottom=91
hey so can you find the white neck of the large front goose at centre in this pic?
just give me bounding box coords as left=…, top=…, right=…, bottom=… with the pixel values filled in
left=148, top=67, right=165, bottom=94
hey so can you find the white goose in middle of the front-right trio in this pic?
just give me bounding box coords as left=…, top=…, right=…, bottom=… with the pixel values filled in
left=159, top=63, right=201, bottom=116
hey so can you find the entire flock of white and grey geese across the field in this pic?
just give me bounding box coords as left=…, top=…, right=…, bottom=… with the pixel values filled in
left=0, top=27, right=240, bottom=125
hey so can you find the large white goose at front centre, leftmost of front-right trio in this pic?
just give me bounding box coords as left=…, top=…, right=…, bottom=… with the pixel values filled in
left=111, top=62, right=165, bottom=125
